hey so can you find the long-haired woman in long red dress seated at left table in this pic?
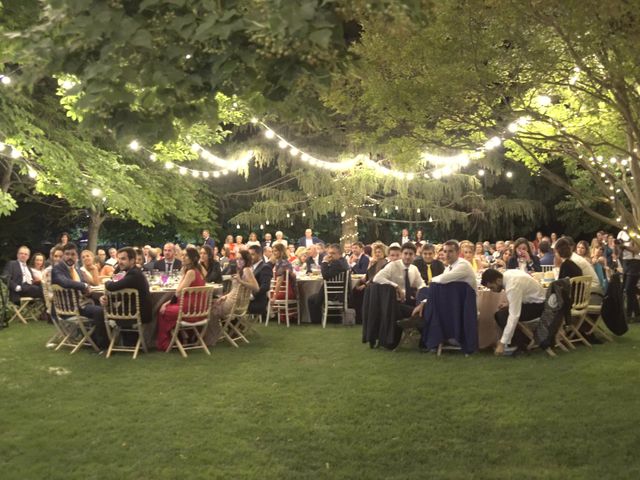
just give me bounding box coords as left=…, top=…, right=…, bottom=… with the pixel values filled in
left=156, top=247, right=205, bottom=350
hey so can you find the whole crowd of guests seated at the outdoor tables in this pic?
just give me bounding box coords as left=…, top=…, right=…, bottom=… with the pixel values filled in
left=0, top=224, right=640, bottom=350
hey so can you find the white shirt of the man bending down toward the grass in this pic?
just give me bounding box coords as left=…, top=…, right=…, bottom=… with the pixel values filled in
left=500, top=269, right=545, bottom=345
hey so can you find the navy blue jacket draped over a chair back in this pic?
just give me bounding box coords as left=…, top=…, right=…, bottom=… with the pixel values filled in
left=418, top=282, right=478, bottom=354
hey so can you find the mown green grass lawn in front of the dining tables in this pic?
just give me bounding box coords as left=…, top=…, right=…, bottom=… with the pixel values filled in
left=0, top=324, right=640, bottom=480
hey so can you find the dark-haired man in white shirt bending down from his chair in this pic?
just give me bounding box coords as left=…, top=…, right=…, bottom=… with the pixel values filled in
left=481, top=269, right=545, bottom=355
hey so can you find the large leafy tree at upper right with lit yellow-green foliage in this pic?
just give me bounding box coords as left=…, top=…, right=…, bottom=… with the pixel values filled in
left=328, top=0, right=640, bottom=236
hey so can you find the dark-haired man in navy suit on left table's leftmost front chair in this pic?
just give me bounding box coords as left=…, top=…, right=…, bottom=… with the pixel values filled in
left=51, top=243, right=108, bottom=349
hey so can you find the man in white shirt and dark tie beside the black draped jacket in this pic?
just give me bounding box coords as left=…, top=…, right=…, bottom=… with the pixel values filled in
left=373, top=243, right=425, bottom=308
